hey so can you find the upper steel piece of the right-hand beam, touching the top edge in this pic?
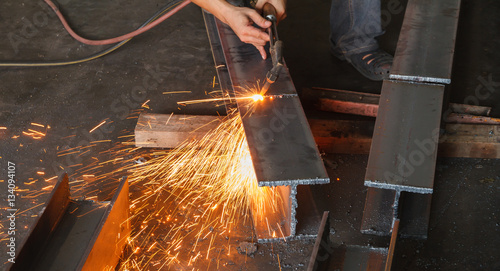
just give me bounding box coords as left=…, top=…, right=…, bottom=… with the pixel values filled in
left=389, top=0, right=460, bottom=84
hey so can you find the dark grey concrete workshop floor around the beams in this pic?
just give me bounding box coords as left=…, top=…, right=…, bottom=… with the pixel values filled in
left=0, top=0, right=500, bottom=270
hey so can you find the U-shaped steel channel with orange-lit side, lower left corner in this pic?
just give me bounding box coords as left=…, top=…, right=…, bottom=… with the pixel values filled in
left=10, top=174, right=131, bottom=270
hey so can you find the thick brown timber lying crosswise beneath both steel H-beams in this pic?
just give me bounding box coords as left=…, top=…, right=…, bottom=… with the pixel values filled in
left=135, top=114, right=500, bottom=158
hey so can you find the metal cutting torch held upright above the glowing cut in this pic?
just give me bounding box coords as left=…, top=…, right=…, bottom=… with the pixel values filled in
left=260, top=3, right=283, bottom=95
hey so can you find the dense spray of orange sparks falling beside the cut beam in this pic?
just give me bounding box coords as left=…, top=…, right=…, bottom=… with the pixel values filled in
left=115, top=110, right=282, bottom=270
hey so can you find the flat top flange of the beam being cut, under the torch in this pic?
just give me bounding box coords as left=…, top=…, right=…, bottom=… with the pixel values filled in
left=205, top=14, right=330, bottom=189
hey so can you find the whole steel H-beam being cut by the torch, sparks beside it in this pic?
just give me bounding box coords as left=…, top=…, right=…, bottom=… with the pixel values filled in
left=203, top=12, right=330, bottom=242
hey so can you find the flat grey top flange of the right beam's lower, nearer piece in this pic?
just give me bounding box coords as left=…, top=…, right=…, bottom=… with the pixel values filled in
left=365, top=81, right=444, bottom=194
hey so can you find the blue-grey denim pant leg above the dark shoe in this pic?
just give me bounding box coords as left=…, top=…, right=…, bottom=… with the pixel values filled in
left=330, top=0, right=383, bottom=57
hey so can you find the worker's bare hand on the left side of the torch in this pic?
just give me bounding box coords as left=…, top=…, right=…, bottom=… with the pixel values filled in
left=223, top=7, right=271, bottom=59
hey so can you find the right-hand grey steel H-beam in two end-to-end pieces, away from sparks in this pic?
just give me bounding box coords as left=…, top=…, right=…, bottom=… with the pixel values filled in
left=361, top=0, right=460, bottom=238
